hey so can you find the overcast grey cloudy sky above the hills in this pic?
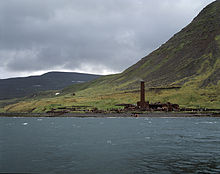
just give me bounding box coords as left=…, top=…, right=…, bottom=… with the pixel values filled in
left=0, top=0, right=214, bottom=78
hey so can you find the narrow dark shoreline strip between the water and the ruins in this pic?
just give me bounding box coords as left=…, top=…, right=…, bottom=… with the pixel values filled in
left=0, top=112, right=220, bottom=118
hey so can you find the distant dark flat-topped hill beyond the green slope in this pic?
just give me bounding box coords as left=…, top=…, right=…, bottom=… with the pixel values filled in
left=0, top=72, right=100, bottom=99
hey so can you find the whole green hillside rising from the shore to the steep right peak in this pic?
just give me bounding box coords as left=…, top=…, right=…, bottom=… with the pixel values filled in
left=2, top=0, right=220, bottom=112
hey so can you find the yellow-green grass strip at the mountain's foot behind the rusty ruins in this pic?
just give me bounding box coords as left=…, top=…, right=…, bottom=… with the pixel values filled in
left=0, top=79, right=220, bottom=112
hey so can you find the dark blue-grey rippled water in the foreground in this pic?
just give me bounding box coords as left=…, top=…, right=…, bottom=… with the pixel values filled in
left=0, top=118, right=220, bottom=174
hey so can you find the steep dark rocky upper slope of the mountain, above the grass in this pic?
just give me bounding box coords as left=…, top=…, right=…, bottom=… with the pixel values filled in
left=106, top=0, right=220, bottom=87
